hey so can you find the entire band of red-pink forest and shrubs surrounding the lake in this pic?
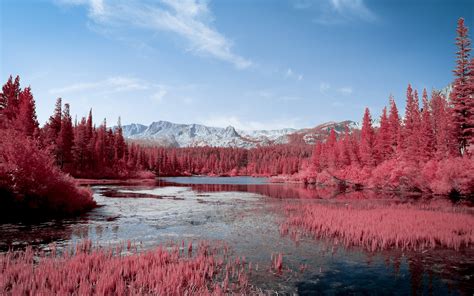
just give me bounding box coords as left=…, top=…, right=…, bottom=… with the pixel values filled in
left=0, top=18, right=474, bottom=214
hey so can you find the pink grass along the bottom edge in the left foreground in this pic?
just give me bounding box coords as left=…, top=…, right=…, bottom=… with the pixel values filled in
left=0, top=241, right=249, bottom=295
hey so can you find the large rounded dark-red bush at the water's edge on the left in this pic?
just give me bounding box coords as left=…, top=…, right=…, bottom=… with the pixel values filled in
left=0, top=130, right=96, bottom=215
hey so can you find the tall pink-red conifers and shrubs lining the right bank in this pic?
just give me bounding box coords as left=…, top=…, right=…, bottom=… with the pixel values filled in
left=296, top=18, right=474, bottom=196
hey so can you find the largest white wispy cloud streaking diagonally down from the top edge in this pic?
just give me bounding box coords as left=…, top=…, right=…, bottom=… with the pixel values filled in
left=56, top=0, right=252, bottom=69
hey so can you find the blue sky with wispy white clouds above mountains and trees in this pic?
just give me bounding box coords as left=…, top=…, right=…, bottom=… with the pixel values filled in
left=0, top=0, right=474, bottom=129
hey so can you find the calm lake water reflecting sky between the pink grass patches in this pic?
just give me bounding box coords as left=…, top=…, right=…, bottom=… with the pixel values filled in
left=0, top=177, right=474, bottom=295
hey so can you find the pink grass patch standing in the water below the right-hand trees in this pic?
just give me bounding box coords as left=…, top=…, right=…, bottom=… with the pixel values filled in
left=280, top=203, right=474, bottom=251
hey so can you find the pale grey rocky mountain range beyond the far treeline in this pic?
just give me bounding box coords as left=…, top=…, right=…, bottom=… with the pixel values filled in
left=123, top=121, right=358, bottom=148
